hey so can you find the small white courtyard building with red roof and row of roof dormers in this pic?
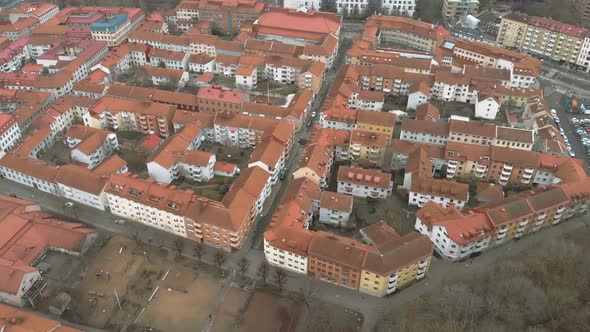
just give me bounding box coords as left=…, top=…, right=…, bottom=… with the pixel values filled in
left=337, top=166, right=393, bottom=198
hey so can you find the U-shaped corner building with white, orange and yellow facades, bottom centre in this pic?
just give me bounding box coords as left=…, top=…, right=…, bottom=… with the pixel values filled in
left=264, top=177, right=432, bottom=296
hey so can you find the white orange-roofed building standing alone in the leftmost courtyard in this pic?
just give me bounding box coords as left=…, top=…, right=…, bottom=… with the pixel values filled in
left=64, top=125, right=119, bottom=169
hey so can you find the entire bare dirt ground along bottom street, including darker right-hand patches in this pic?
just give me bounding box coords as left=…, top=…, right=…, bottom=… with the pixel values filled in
left=39, top=236, right=362, bottom=332
